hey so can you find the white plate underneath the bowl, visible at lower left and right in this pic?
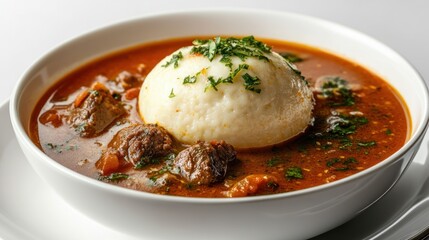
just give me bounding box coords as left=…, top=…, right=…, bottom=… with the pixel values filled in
left=0, top=98, right=429, bottom=240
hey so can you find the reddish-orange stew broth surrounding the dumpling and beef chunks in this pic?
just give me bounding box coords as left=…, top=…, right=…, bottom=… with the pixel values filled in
left=30, top=38, right=409, bottom=197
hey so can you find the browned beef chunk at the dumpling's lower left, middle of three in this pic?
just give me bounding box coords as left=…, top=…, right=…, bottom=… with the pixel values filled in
left=107, top=124, right=173, bottom=166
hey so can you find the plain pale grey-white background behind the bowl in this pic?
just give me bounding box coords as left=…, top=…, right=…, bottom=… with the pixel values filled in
left=0, top=0, right=429, bottom=103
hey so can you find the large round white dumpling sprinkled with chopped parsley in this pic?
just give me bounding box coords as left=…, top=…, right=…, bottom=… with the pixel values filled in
left=139, top=36, right=314, bottom=149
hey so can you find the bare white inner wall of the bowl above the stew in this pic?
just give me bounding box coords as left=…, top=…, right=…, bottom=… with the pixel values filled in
left=11, top=10, right=428, bottom=195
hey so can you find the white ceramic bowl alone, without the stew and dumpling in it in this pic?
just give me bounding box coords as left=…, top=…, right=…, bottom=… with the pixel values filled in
left=10, top=10, right=428, bottom=239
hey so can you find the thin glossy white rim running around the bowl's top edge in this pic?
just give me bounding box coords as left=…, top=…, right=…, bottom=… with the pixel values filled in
left=9, top=8, right=429, bottom=204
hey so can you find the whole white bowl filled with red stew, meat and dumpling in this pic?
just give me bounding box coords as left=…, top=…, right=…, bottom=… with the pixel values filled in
left=11, top=8, right=428, bottom=239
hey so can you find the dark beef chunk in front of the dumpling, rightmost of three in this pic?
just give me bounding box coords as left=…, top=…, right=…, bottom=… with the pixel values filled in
left=173, top=141, right=236, bottom=184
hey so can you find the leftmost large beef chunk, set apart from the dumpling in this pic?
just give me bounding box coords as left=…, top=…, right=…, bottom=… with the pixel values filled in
left=67, top=90, right=126, bottom=138
